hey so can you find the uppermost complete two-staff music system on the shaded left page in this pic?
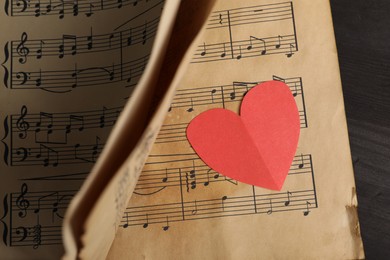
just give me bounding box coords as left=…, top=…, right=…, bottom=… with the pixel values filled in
left=2, top=1, right=164, bottom=93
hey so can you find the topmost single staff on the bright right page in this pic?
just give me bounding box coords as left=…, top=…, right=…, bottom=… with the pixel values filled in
left=206, top=2, right=293, bottom=29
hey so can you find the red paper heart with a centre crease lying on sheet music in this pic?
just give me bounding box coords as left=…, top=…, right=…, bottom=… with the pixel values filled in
left=187, top=81, right=300, bottom=190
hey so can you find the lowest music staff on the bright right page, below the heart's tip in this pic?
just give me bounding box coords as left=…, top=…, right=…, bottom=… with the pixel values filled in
left=120, top=190, right=318, bottom=231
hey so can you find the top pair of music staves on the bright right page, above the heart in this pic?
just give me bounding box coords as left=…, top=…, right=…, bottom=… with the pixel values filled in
left=192, top=2, right=298, bottom=63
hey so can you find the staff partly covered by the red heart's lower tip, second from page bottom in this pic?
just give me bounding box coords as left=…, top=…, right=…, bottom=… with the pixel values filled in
left=135, top=154, right=312, bottom=192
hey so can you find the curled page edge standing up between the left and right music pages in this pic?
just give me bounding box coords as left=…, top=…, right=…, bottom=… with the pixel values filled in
left=64, top=0, right=214, bottom=259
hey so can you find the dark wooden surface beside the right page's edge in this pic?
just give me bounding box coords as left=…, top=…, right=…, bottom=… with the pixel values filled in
left=330, top=0, right=390, bottom=259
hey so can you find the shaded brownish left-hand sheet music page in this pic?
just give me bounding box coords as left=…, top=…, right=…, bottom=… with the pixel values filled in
left=0, top=0, right=164, bottom=259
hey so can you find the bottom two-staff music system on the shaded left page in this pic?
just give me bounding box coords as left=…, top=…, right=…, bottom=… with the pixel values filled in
left=0, top=183, right=77, bottom=249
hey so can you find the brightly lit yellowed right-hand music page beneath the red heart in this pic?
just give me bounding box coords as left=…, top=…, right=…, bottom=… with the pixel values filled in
left=108, top=0, right=364, bottom=259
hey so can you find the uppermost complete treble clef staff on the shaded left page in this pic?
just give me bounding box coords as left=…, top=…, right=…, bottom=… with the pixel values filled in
left=11, top=17, right=160, bottom=64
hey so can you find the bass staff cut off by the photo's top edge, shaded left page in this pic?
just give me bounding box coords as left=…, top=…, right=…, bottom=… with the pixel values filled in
left=4, top=0, right=157, bottom=19
